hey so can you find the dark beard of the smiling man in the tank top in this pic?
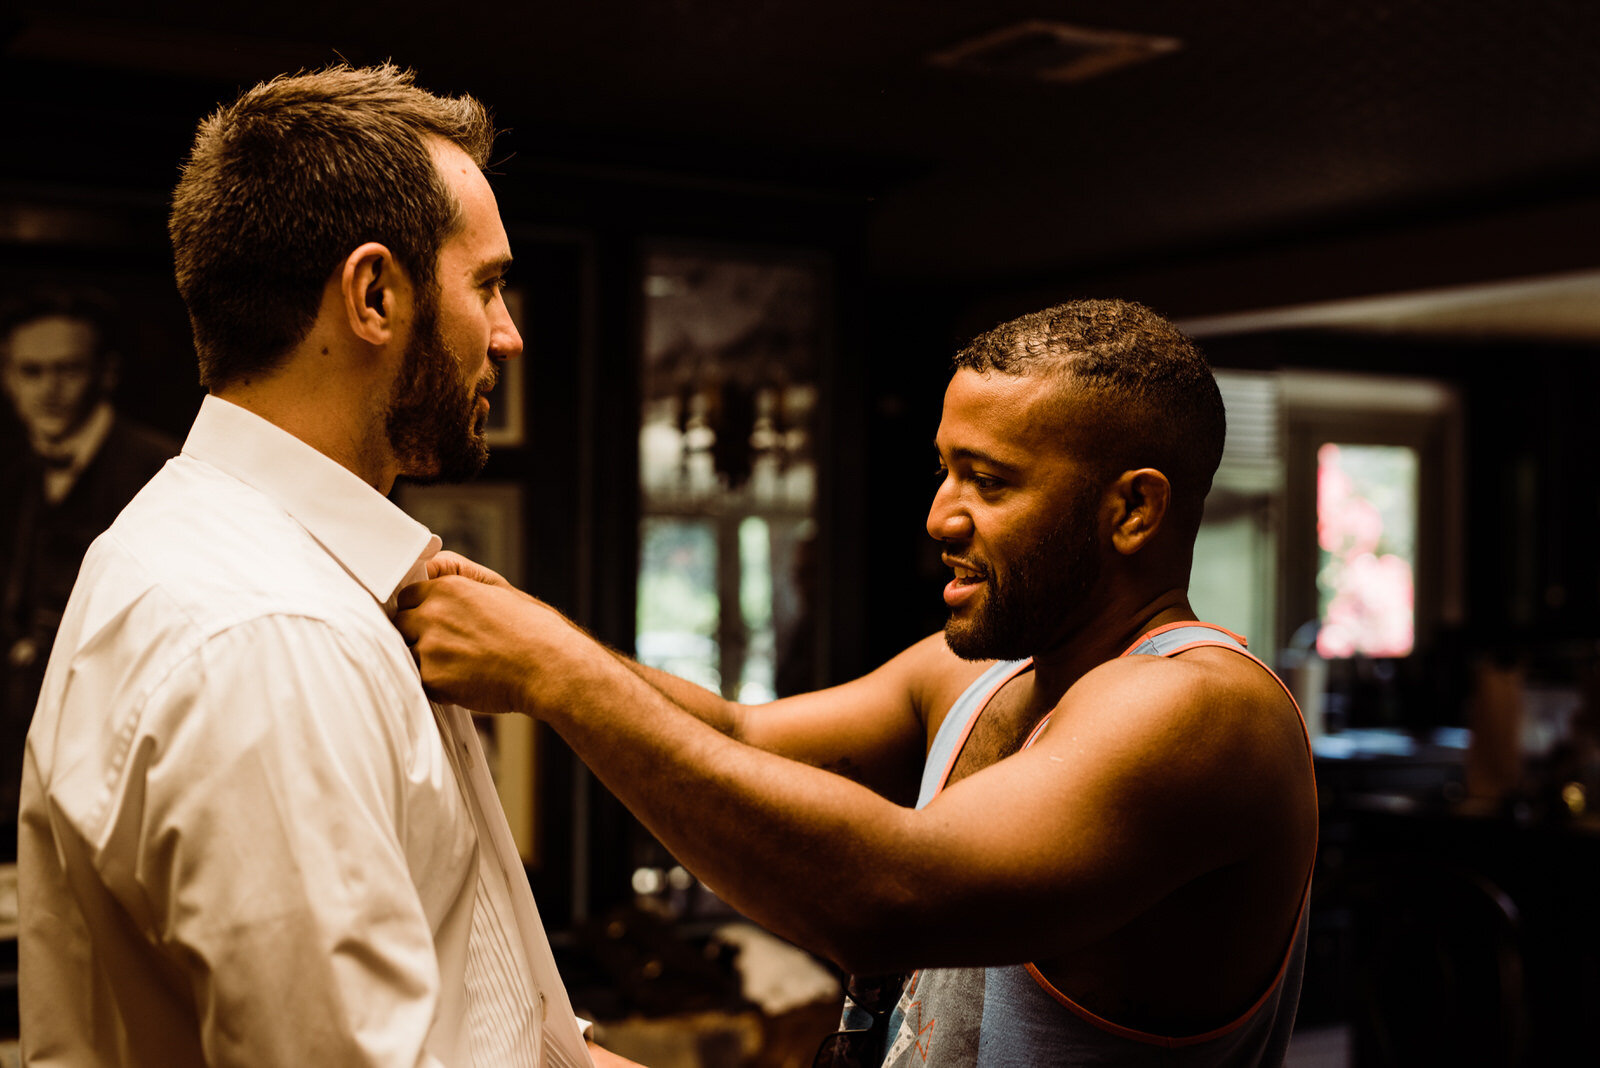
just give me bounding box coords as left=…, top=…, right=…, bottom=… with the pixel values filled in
left=944, top=492, right=1101, bottom=660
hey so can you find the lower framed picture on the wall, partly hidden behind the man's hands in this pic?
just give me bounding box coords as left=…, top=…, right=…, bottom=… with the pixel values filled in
left=397, top=479, right=539, bottom=863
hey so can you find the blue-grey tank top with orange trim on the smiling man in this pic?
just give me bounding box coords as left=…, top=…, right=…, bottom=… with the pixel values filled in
left=883, top=624, right=1310, bottom=1068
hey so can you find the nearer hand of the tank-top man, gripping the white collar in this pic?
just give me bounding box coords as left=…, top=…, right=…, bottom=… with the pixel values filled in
left=395, top=565, right=581, bottom=715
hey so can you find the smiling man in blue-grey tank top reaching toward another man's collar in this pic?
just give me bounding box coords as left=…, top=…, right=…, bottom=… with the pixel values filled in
left=400, top=301, right=1317, bottom=1066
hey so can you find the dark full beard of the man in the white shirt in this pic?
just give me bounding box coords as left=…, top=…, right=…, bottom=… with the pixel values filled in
left=384, top=293, right=499, bottom=483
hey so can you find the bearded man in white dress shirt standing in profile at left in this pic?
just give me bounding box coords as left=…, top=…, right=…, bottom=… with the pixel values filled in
left=19, top=66, right=630, bottom=1068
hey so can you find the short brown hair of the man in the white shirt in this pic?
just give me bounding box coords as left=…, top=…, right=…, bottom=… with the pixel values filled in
left=168, top=64, right=494, bottom=389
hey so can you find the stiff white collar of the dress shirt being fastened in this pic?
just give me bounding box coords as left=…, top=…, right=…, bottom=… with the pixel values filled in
left=184, top=395, right=440, bottom=603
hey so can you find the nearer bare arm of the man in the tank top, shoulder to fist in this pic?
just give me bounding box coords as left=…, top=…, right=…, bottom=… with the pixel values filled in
left=400, top=580, right=1304, bottom=972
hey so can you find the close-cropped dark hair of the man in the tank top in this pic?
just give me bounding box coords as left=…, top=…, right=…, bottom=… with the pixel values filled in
left=955, top=301, right=1227, bottom=524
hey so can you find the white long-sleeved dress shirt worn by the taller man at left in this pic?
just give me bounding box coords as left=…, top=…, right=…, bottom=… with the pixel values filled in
left=18, top=397, right=589, bottom=1068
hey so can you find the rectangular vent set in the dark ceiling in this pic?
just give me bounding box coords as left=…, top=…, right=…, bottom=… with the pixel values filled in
left=928, top=19, right=1182, bottom=82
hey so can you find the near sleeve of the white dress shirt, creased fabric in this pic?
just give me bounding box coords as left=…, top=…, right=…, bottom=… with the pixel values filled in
left=107, top=617, right=457, bottom=1068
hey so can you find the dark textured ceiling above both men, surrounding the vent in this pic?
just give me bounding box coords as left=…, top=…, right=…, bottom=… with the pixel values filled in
left=3, top=0, right=1600, bottom=281
